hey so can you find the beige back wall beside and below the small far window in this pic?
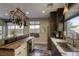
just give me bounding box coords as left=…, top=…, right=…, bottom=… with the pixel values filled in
left=31, top=18, right=49, bottom=44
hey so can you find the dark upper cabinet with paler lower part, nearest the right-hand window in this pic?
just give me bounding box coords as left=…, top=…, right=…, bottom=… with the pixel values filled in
left=57, top=8, right=64, bottom=32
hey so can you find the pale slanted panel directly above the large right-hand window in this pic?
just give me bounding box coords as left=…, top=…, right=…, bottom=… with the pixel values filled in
left=65, top=4, right=79, bottom=20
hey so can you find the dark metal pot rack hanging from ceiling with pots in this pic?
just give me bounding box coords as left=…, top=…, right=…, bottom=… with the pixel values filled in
left=9, top=8, right=29, bottom=27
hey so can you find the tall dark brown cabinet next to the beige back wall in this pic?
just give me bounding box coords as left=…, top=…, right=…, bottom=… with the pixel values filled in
left=49, top=11, right=57, bottom=37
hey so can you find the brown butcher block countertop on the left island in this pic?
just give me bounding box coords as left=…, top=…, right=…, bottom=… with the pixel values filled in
left=0, top=37, right=33, bottom=50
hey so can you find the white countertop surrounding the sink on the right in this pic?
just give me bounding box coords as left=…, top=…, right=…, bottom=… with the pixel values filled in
left=51, top=37, right=79, bottom=56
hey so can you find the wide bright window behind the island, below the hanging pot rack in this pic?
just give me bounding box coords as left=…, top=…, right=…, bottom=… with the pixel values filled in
left=7, top=23, right=23, bottom=37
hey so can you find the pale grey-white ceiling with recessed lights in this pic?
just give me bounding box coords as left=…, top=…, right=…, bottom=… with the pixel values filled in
left=0, top=3, right=64, bottom=19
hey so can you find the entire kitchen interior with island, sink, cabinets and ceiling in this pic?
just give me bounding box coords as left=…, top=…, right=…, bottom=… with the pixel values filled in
left=0, top=3, right=79, bottom=56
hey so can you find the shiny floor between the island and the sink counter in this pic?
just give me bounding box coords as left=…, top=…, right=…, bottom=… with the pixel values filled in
left=31, top=44, right=51, bottom=56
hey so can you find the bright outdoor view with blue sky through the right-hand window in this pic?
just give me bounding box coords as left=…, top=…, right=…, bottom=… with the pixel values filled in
left=67, top=16, right=79, bottom=37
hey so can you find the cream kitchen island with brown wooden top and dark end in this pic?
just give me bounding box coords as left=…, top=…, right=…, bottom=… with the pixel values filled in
left=0, top=37, right=34, bottom=56
